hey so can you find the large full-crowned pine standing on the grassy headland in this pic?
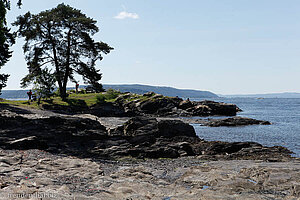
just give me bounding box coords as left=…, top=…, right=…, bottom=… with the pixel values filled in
left=14, top=4, right=113, bottom=100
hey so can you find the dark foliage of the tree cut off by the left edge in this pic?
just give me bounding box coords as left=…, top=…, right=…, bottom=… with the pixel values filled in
left=0, top=0, right=21, bottom=94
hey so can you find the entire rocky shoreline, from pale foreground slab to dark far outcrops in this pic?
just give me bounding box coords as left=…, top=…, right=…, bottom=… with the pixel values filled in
left=0, top=94, right=300, bottom=199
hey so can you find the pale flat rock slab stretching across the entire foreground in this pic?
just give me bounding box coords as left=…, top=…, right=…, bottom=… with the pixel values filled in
left=0, top=150, right=300, bottom=200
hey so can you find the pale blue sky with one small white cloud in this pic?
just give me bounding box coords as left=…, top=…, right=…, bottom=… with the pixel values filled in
left=0, top=0, right=300, bottom=94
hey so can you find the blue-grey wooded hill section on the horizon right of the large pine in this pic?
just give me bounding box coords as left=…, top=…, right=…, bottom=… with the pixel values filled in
left=103, top=84, right=218, bottom=98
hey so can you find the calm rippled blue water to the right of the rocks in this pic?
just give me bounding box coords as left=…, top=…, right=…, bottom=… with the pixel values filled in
left=193, top=98, right=300, bottom=157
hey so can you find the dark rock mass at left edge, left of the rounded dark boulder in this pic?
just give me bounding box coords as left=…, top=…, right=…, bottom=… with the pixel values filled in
left=0, top=116, right=107, bottom=154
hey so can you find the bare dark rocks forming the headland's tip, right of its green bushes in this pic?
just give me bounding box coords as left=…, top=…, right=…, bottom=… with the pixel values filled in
left=116, top=93, right=240, bottom=117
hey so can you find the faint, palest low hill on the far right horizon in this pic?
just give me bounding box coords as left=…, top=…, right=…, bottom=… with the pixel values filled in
left=220, top=92, right=300, bottom=98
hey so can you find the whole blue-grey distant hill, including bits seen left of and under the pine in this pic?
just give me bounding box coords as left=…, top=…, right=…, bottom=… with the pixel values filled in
left=0, top=84, right=218, bottom=99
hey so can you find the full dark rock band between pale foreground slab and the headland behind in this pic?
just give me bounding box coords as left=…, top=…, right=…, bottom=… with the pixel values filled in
left=0, top=111, right=291, bottom=161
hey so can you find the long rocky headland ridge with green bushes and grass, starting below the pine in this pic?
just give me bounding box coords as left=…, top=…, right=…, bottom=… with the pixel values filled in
left=38, top=92, right=241, bottom=117
